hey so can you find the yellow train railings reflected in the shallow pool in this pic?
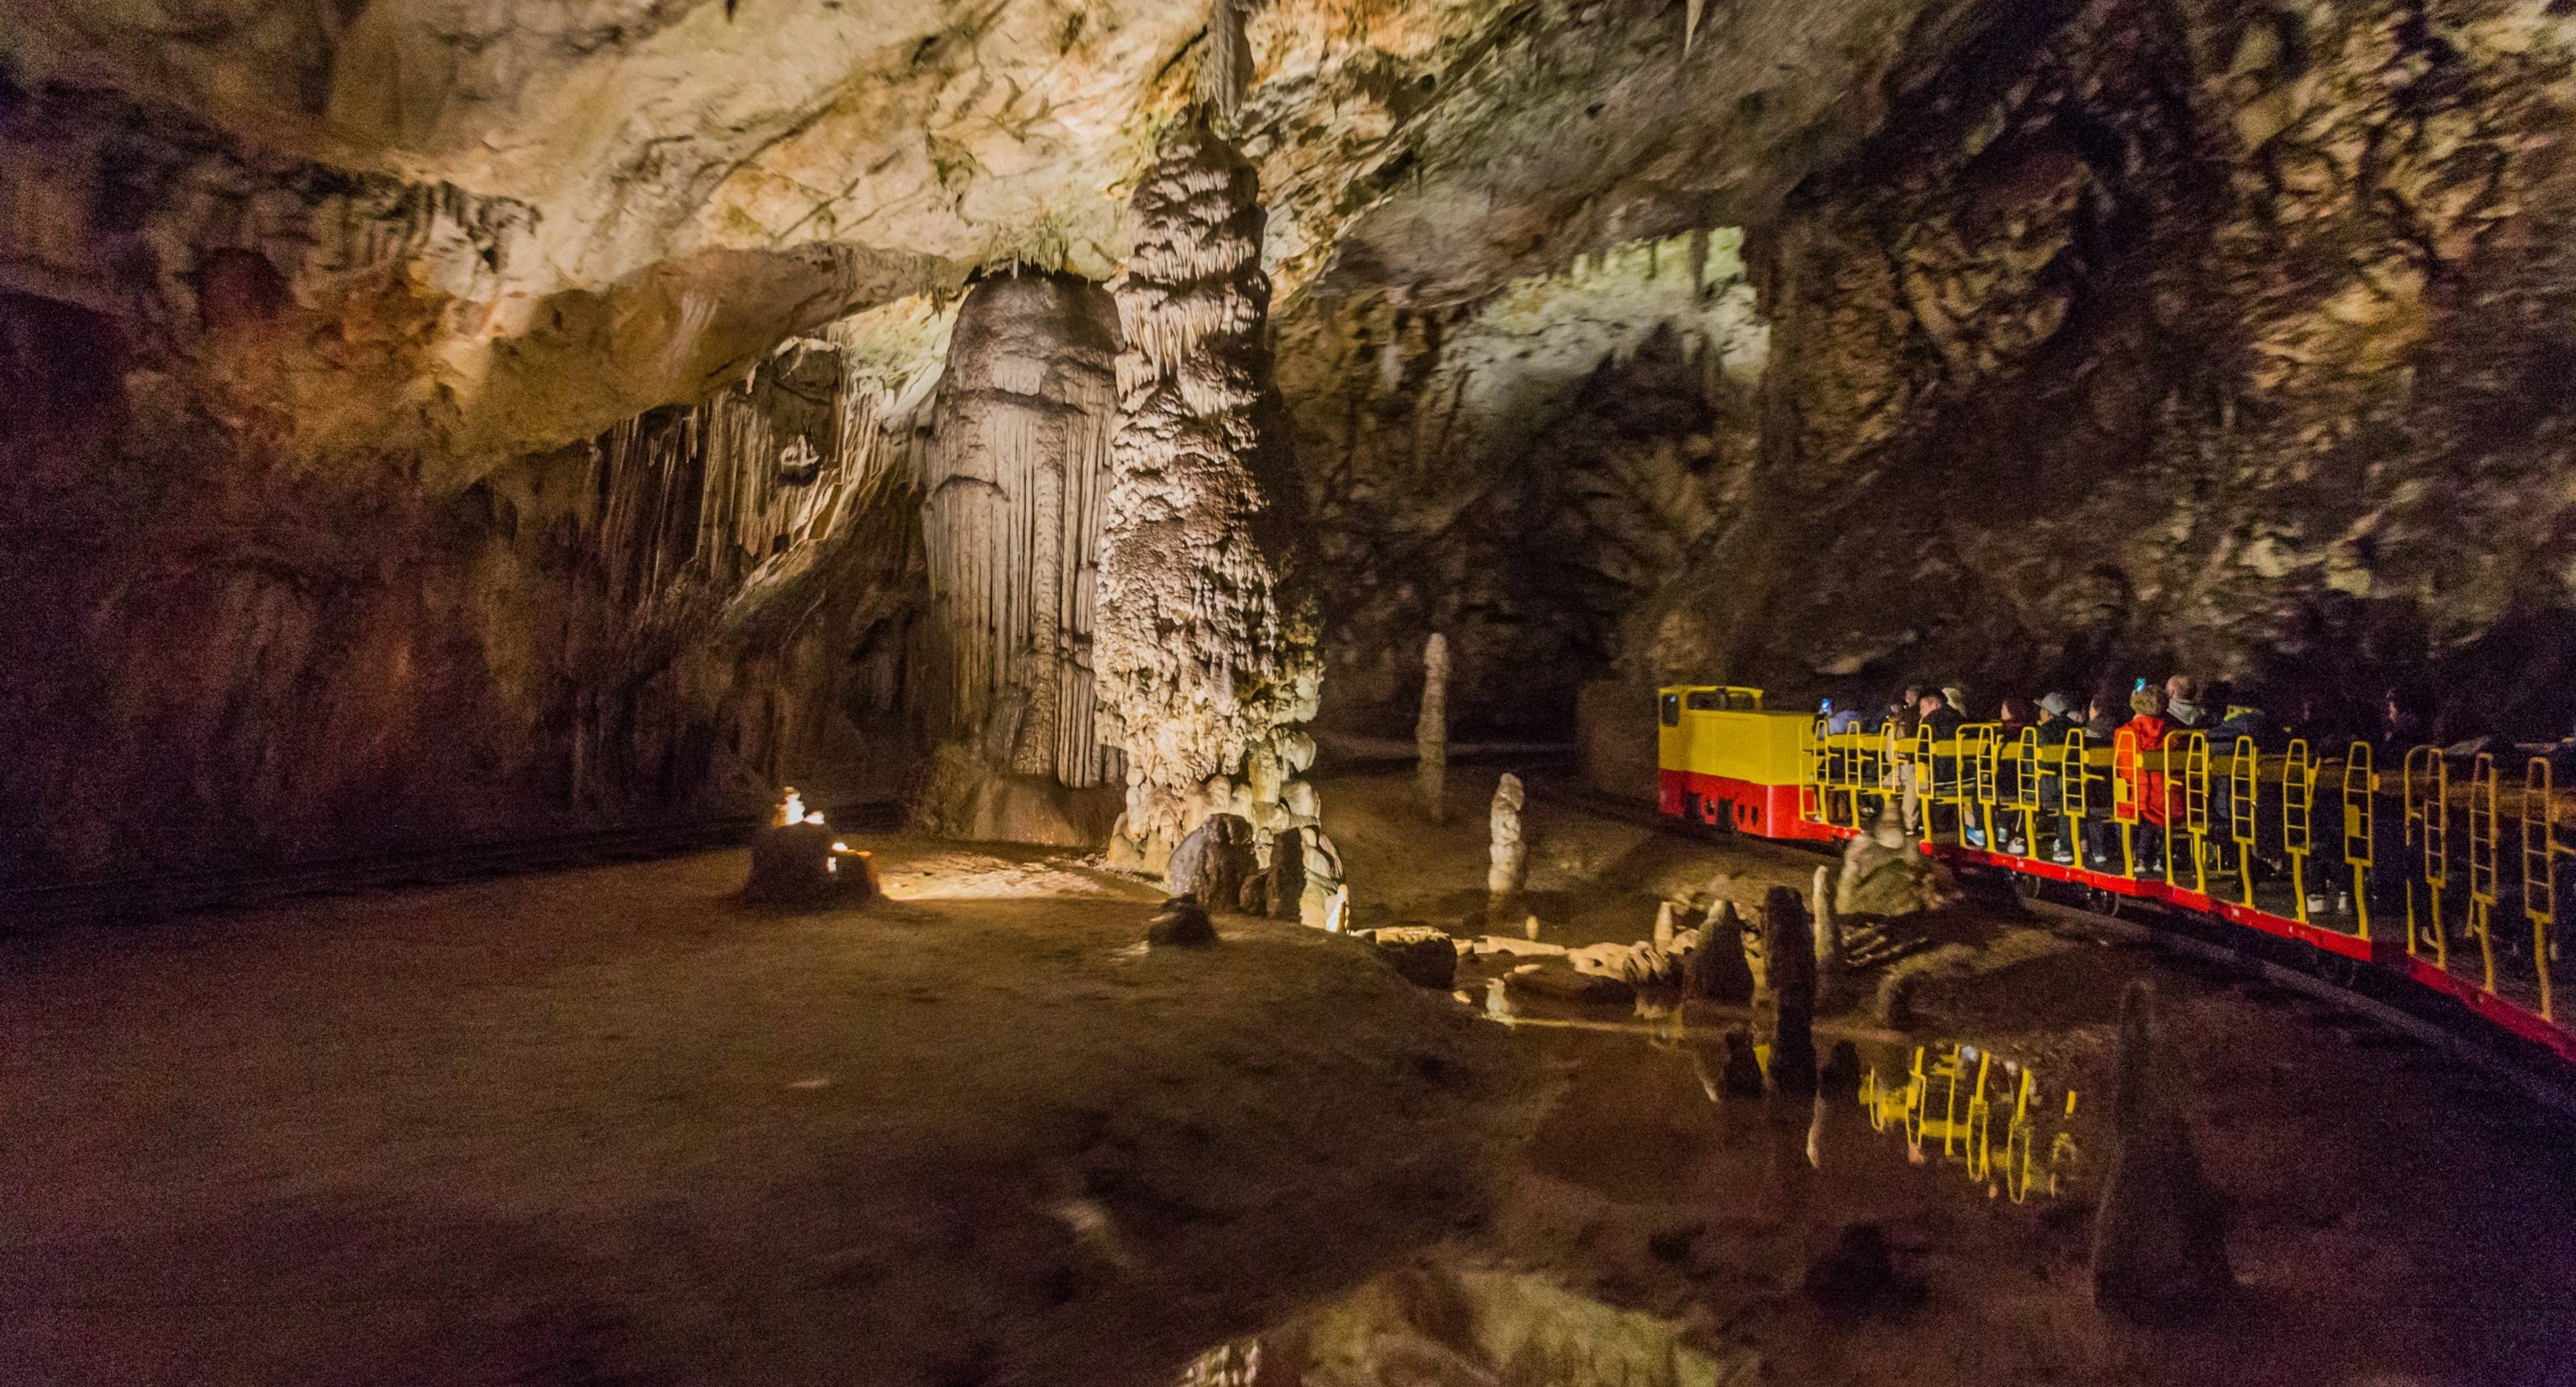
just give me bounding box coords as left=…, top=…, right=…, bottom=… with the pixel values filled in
left=1860, top=1045, right=2076, bottom=1205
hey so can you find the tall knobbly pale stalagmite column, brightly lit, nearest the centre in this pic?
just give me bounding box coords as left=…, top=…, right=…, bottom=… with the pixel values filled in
left=1097, top=118, right=1322, bottom=873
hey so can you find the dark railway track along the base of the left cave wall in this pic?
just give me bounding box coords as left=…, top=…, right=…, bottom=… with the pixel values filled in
left=0, top=803, right=896, bottom=934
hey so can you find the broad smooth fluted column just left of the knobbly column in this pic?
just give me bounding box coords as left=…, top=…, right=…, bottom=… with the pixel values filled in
left=922, top=273, right=1118, bottom=787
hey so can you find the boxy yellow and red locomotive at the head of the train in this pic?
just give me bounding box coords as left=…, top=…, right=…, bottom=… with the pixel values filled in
left=1656, top=685, right=1834, bottom=842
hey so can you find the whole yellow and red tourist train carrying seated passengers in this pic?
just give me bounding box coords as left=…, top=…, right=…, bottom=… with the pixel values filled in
left=1656, top=685, right=2576, bottom=1063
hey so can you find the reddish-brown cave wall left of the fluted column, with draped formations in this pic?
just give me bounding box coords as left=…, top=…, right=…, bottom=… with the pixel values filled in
left=0, top=284, right=932, bottom=883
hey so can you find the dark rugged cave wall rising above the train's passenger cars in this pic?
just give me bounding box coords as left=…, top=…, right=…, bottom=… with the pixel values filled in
left=1620, top=0, right=2576, bottom=751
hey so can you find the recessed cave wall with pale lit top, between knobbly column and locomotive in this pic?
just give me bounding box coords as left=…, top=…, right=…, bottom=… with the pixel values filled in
left=1278, top=229, right=1767, bottom=738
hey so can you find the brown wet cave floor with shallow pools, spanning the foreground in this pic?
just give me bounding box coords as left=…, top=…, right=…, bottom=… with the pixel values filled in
left=0, top=767, right=2576, bottom=1387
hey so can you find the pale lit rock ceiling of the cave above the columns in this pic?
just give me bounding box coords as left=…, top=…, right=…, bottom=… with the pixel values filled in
left=0, top=0, right=1976, bottom=465
